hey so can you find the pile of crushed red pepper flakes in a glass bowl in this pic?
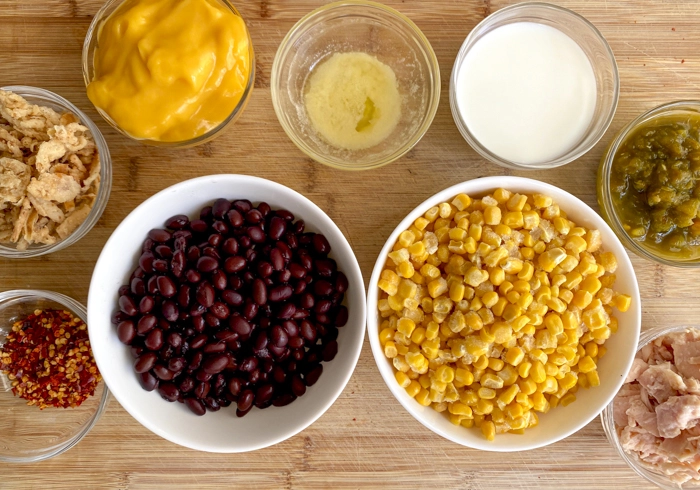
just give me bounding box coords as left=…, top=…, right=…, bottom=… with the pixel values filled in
left=0, top=309, right=102, bottom=409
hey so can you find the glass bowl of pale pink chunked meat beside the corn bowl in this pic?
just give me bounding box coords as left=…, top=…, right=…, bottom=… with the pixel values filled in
left=601, top=325, right=700, bottom=490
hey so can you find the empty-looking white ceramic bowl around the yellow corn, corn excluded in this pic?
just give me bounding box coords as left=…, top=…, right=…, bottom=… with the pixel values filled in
left=367, top=177, right=642, bottom=452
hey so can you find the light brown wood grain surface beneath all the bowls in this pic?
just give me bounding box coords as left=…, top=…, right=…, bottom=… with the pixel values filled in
left=0, top=0, right=700, bottom=490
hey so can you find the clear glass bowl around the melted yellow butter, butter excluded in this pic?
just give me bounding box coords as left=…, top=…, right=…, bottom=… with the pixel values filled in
left=270, top=0, right=440, bottom=170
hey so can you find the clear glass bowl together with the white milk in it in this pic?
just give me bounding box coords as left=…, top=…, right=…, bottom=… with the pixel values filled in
left=450, top=2, right=620, bottom=169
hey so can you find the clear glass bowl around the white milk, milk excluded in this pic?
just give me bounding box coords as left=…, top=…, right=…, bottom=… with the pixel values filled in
left=450, top=2, right=620, bottom=170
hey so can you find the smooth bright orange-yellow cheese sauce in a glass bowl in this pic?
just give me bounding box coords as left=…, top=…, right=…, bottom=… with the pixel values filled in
left=87, top=0, right=252, bottom=142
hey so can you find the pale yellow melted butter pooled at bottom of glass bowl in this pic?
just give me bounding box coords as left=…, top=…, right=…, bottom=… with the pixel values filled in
left=304, top=52, right=401, bottom=150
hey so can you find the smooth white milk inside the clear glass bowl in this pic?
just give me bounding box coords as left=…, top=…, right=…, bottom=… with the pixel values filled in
left=456, top=22, right=596, bottom=164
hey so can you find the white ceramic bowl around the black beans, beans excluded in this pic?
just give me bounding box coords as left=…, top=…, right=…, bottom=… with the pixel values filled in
left=88, top=175, right=366, bottom=453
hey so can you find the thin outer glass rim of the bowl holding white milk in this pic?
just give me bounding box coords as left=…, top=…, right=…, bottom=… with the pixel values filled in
left=450, top=2, right=620, bottom=170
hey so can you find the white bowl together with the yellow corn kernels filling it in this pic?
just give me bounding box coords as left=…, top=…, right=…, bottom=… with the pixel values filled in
left=367, top=177, right=641, bottom=452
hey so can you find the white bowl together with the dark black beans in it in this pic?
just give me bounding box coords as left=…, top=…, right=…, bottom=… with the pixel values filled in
left=88, top=175, right=366, bottom=453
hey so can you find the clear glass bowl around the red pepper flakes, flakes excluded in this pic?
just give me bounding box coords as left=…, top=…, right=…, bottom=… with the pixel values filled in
left=0, top=289, right=109, bottom=463
